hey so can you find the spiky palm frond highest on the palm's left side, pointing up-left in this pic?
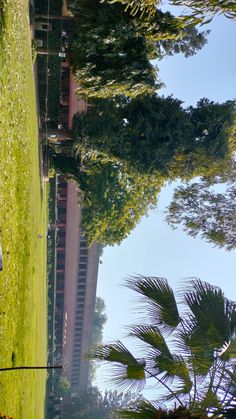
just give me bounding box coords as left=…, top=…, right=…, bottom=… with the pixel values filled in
left=126, top=276, right=181, bottom=331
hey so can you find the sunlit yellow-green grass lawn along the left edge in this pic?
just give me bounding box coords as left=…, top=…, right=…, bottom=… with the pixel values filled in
left=0, top=0, right=47, bottom=419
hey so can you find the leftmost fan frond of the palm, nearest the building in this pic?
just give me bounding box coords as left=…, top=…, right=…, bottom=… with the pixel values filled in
left=92, top=341, right=146, bottom=390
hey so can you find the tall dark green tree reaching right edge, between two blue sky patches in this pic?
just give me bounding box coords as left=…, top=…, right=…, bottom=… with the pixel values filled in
left=74, top=95, right=235, bottom=179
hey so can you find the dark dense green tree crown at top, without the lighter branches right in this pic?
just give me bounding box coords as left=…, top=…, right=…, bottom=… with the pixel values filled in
left=66, top=0, right=158, bottom=97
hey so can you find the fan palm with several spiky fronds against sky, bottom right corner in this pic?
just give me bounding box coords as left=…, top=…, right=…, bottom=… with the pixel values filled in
left=93, top=276, right=236, bottom=419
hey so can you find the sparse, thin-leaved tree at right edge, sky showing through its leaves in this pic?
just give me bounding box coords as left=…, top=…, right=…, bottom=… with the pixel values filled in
left=166, top=179, right=236, bottom=250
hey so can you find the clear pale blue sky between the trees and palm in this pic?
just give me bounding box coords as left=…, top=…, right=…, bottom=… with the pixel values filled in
left=94, top=13, right=236, bottom=389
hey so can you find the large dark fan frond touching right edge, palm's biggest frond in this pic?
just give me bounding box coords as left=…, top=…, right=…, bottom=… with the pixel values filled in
left=184, top=279, right=236, bottom=350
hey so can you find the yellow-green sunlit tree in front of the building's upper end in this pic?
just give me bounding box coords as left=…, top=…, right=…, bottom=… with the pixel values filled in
left=50, top=146, right=164, bottom=246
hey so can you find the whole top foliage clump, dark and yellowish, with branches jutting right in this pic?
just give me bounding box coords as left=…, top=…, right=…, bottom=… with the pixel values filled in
left=68, top=0, right=206, bottom=98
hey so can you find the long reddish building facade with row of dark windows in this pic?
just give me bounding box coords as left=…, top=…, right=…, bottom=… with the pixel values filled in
left=54, top=176, right=100, bottom=396
